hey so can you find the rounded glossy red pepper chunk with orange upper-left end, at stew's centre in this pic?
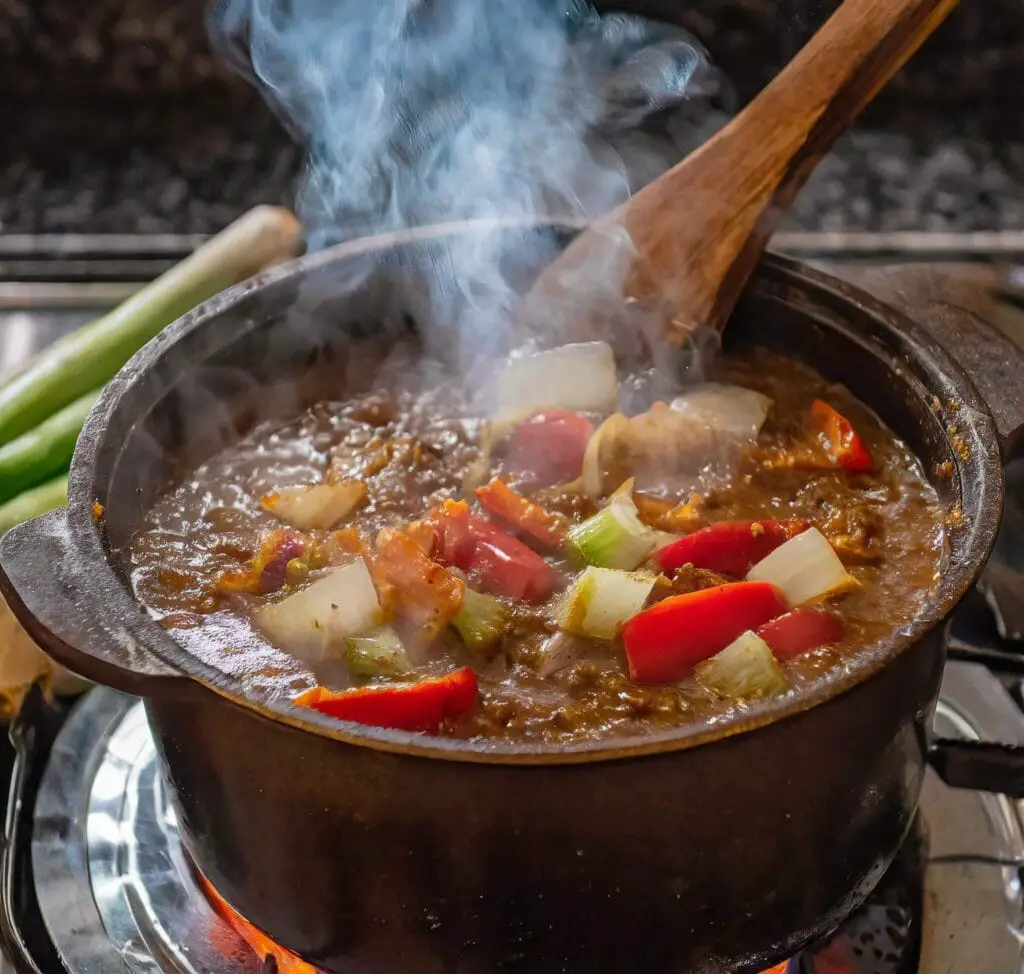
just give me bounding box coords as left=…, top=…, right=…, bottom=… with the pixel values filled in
left=428, top=501, right=557, bottom=602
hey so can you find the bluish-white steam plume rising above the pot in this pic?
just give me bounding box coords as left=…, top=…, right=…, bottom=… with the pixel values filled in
left=210, top=0, right=721, bottom=374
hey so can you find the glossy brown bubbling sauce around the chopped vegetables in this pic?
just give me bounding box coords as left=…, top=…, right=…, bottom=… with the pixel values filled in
left=132, top=350, right=943, bottom=740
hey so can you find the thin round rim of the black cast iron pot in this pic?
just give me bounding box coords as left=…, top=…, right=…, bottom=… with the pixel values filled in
left=68, top=217, right=1004, bottom=765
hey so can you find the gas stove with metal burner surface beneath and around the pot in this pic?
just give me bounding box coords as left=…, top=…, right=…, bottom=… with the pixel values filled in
left=0, top=237, right=1024, bottom=974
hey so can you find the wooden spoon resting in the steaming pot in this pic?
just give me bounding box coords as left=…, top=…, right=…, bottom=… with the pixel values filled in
left=523, top=0, right=956, bottom=343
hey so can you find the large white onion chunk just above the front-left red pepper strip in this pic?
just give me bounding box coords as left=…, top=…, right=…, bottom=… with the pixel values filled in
left=255, top=558, right=380, bottom=663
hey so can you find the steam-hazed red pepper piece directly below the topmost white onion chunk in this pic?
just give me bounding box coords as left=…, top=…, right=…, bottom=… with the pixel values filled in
left=507, top=410, right=594, bottom=486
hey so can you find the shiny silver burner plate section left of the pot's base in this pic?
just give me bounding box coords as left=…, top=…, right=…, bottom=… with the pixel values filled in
left=32, top=689, right=264, bottom=974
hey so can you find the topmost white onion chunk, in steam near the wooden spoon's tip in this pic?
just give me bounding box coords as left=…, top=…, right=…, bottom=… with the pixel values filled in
left=495, top=342, right=618, bottom=424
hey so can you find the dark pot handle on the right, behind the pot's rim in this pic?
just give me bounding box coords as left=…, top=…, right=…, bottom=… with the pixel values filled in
left=834, top=264, right=1024, bottom=457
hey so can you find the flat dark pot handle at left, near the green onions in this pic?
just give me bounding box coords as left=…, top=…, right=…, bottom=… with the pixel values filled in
left=0, top=508, right=197, bottom=696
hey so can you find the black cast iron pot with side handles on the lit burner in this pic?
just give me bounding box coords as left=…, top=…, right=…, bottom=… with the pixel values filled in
left=0, top=223, right=1024, bottom=974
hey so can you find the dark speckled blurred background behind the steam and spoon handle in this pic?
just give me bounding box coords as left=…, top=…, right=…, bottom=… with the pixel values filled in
left=0, top=0, right=1024, bottom=234
